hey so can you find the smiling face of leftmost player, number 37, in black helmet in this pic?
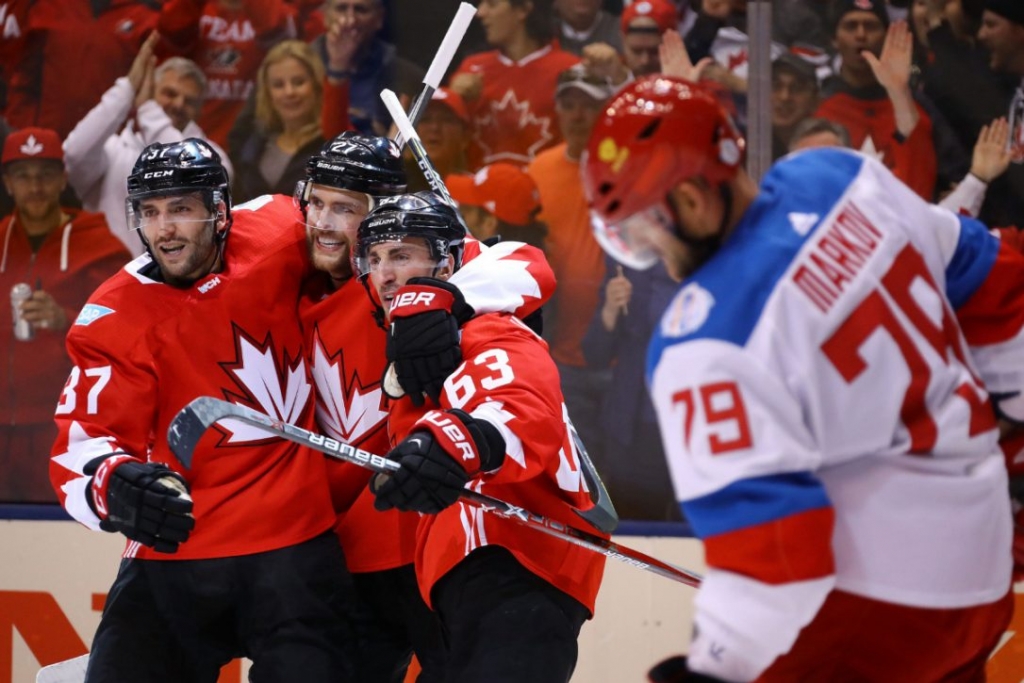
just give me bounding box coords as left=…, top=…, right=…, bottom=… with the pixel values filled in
left=138, top=193, right=222, bottom=287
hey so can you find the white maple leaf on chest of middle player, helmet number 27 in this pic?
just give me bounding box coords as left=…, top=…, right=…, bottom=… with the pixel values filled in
left=312, top=330, right=387, bottom=443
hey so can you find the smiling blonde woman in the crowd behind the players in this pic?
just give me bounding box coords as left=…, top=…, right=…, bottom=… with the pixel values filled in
left=232, top=40, right=325, bottom=202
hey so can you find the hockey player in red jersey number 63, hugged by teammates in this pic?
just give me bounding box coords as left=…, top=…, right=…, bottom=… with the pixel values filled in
left=354, top=193, right=604, bottom=683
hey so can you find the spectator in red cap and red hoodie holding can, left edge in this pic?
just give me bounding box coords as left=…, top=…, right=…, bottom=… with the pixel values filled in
left=0, top=128, right=131, bottom=503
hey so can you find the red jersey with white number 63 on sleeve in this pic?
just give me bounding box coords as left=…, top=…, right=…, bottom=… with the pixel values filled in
left=388, top=314, right=605, bottom=612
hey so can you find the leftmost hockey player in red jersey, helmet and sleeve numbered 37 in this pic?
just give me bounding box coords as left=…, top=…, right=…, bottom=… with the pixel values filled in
left=50, top=138, right=353, bottom=683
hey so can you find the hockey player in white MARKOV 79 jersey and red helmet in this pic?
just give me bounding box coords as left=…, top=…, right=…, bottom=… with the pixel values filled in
left=584, top=72, right=1024, bottom=683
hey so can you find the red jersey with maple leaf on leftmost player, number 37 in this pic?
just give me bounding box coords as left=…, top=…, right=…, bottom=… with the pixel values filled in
left=50, top=197, right=335, bottom=560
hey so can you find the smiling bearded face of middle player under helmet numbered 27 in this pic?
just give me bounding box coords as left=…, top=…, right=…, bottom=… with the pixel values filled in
left=306, top=184, right=370, bottom=281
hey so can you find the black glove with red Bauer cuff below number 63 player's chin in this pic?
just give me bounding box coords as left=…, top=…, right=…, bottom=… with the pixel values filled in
left=384, top=278, right=474, bottom=405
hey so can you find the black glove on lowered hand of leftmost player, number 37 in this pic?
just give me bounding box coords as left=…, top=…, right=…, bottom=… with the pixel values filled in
left=83, top=453, right=196, bottom=553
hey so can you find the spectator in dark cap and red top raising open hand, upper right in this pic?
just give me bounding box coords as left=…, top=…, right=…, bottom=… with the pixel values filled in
left=815, top=0, right=938, bottom=201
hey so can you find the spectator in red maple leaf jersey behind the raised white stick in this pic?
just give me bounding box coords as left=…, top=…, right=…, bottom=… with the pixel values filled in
left=450, top=0, right=580, bottom=170
